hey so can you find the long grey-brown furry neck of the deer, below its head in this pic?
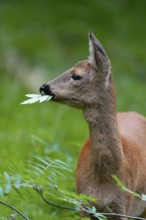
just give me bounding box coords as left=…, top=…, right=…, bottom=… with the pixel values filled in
left=84, top=95, right=122, bottom=179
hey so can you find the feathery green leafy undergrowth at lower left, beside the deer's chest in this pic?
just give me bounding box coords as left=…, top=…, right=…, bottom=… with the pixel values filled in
left=0, top=156, right=106, bottom=219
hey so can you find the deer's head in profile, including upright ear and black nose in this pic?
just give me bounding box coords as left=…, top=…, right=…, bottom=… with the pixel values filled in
left=40, top=33, right=111, bottom=109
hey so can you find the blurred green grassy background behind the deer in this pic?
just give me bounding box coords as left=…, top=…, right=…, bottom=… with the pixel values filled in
left=0, top=0, right=146, bottom=220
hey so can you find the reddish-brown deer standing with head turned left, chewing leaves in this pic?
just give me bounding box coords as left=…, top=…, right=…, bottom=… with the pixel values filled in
left=40, top=33, right=146, bottom=219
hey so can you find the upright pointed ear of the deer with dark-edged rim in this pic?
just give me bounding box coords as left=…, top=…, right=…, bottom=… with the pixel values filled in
left=89, top=32, right=110, bottom=75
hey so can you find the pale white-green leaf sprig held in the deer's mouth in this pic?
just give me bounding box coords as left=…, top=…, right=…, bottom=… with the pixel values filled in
left=20, top=94, right=52, bottom=105
